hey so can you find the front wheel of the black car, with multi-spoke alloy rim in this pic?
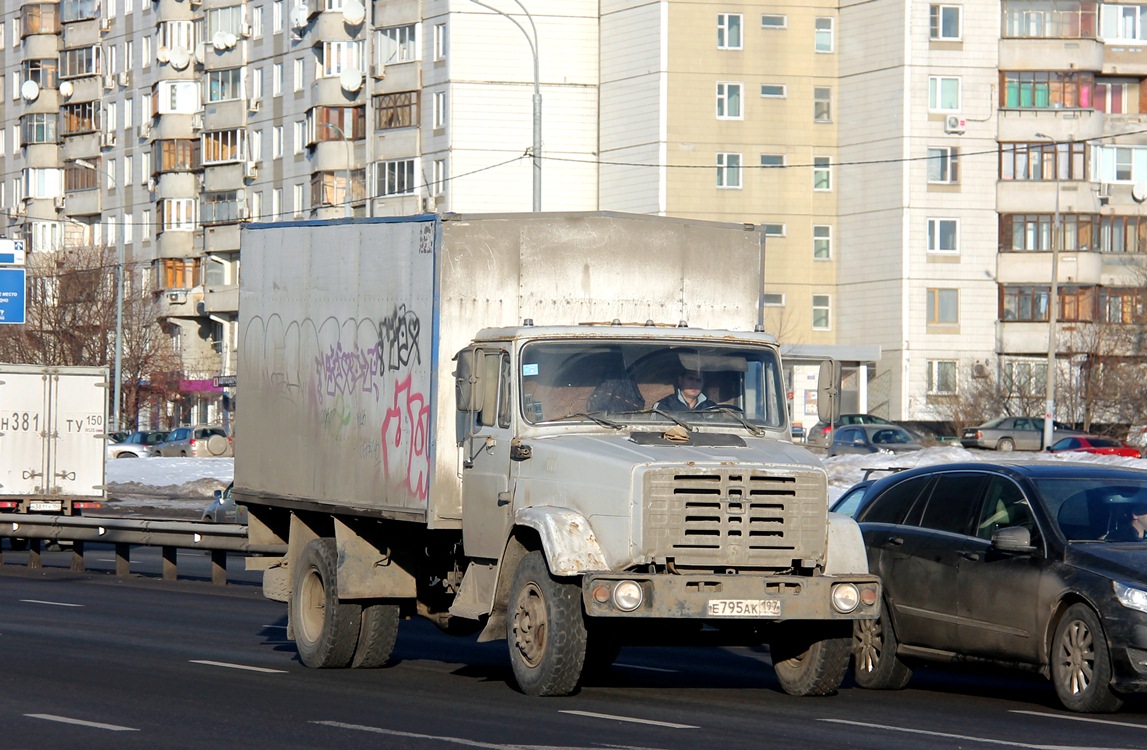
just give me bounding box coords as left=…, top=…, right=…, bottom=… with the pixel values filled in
left=1051, top=604, right=1123, bottom=713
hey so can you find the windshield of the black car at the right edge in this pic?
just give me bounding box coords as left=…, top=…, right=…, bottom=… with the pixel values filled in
left=1036, top=477, right=1147, bottom=541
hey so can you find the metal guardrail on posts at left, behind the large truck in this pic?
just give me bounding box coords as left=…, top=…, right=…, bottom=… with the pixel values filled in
left=0, top=513, right=287, bottom=586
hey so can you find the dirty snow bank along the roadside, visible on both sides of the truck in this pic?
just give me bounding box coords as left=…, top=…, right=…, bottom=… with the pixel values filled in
left=107, top=446, right=1147, bottom=509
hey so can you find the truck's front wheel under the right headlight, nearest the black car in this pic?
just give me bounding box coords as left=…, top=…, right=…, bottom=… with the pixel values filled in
left=768, top=622, right=852, bottom=696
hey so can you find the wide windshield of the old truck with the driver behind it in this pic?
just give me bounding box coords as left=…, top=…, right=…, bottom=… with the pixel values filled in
left=518, top=339, right=785, bottom=429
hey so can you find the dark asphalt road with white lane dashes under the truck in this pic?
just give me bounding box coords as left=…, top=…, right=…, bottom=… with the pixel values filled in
left=0, top=549, right=1147, bottom=750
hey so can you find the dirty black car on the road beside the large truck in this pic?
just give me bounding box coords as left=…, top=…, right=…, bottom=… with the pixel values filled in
left=839, top=462, right=1147, bottom=712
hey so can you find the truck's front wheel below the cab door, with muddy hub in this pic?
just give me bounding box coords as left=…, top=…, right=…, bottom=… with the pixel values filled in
left=506, top=550, right=586, bottom=695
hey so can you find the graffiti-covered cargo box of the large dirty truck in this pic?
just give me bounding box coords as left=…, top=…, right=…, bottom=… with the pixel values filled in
left=235, top=213, right=762, bottom=528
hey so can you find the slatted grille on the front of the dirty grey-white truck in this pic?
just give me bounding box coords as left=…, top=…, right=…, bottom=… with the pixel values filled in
left=643, top=467, right=828, bottom=568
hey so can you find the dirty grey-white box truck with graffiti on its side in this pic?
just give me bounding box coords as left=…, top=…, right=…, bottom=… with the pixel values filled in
left=234, top=213, right=880, bottom=695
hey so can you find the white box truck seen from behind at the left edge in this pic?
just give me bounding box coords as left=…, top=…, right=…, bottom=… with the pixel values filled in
left=0, top=365, right=108, bottom=515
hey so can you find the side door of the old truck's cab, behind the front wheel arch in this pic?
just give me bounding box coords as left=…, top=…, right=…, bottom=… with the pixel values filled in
left=462, top=349, right=514, bottom=560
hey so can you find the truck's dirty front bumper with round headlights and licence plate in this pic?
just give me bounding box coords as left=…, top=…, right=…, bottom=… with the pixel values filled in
left=582, top=573, right=881, bottom=620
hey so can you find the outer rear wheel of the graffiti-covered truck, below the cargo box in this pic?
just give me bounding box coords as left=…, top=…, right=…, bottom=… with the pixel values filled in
left=288, top=539, right=362, bottom=670
